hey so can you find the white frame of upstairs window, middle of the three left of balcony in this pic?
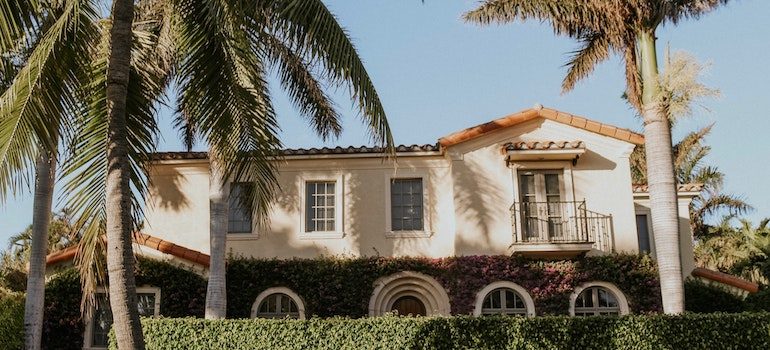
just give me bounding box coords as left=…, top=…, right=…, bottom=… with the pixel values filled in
left=299, top=173, right=345, bottom=239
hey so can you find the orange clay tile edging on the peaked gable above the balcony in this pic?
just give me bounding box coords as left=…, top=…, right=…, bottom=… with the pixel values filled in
left=439, top=106, right=644, bottom=147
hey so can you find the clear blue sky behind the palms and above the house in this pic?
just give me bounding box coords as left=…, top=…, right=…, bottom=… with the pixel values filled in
left=0, top=0, right=770, bottom=246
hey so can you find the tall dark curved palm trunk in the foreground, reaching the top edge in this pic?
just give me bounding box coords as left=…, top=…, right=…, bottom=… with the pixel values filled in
left=106, top=0, right=144, bottom=349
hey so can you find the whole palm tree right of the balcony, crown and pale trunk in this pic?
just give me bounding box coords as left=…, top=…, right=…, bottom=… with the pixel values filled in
left=465, top=0, right=727, bottom=314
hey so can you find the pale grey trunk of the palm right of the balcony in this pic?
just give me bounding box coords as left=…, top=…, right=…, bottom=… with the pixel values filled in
left=638, top=30, right=684, bottom=314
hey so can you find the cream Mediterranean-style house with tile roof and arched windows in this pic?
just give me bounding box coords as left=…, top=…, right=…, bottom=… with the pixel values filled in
left=43, top=106, right=755, bottom=347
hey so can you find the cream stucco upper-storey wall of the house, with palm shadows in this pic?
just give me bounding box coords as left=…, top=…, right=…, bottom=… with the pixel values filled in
left=145, top=119, right=692, bottom=266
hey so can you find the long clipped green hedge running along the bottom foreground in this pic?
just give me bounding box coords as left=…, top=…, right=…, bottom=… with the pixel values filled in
left=110, top=313, right=770, bottom=350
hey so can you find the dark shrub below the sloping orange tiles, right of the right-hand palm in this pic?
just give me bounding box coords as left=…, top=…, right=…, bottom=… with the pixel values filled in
left=684, top=279, right=745, bottom=313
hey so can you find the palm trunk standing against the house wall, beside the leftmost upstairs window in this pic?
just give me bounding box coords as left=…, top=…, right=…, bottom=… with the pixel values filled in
left=206, top=157, right=229, bottom=319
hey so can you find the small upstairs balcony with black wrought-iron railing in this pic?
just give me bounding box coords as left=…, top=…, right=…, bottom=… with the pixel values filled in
left=511, top=201, right=613, bottom=257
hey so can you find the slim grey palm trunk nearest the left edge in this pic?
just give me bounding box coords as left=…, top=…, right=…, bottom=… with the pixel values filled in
left=24, top=151, right=56, bottom=350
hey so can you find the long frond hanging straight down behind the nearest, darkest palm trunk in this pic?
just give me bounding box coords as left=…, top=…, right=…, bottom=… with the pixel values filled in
left=63, top=13, right=170, bottom=311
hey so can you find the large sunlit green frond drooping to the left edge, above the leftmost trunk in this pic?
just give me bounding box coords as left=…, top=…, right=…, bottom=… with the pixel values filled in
left=0, top=0, right=96, bottom=200
